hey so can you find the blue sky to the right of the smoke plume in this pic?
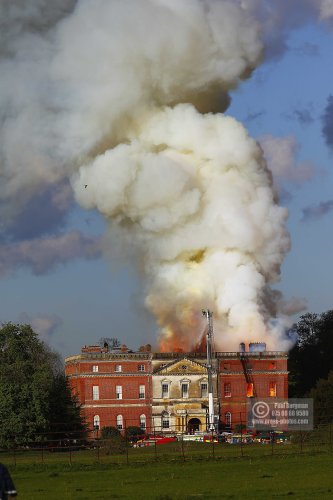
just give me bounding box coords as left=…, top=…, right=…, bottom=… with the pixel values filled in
left=228, top=22, right=333, bottom=318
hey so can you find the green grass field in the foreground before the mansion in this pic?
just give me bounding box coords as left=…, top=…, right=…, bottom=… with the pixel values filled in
left=1, top=443, right=333, bottom=500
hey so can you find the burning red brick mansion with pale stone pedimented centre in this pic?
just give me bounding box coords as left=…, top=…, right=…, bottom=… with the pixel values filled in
left=65, top=343, right=288, bottom=433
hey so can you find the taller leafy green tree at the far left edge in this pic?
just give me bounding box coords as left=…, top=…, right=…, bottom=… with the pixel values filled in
left=0, top=323, right=56, bottom=445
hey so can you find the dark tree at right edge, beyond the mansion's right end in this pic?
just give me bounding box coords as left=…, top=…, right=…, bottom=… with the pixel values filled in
left=289, top=311, right=333, bottom=396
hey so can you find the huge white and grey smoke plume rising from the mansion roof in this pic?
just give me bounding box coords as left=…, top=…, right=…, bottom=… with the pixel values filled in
left=4, top=0, right=312, bottom=350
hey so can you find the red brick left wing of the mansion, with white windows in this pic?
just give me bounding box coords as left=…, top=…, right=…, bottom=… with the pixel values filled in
left=65, top=352, right=151, bottom=434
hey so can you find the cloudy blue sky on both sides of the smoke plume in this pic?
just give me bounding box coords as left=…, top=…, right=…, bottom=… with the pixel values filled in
left=0, top=1, right=333, bottom=356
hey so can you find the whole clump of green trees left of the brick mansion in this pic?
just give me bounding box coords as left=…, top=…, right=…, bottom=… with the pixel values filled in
left=0, top=323, right=87, bottom=446
